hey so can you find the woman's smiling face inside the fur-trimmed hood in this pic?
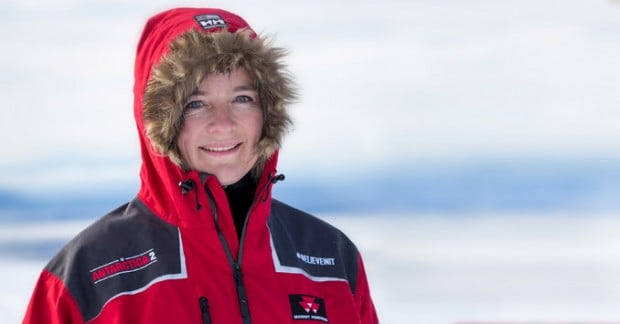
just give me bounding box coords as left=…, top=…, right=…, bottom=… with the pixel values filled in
left=177, top=68, right=263, bottom=185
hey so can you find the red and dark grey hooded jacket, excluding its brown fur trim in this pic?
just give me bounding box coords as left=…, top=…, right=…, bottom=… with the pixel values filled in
left=23, top=8, right=378, bottom=324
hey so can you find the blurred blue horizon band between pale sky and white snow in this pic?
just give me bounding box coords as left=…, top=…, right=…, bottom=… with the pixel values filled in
left=0, top=155, right=620, bottom=221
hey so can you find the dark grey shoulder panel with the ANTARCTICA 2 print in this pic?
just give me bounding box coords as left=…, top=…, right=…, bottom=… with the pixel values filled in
left=46, top=199, right=187, bottom=321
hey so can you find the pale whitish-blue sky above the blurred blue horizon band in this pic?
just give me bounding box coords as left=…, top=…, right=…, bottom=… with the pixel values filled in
left=0, top=0, right=620, bottom=188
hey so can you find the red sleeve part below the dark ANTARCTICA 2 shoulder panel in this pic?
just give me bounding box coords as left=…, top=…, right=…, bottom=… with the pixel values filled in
left=22, top=270, right=84, bottom=324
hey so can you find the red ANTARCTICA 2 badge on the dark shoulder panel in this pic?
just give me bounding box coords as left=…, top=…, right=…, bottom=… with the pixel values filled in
left=90, top=249, right=157, bottom=284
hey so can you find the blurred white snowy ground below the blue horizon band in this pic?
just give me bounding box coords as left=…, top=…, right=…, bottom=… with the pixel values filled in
left=0, top=214, right=620, bottom=324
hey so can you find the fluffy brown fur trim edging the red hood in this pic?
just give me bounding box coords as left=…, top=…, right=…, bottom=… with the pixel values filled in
left=143, top=29, right=296, bottom=175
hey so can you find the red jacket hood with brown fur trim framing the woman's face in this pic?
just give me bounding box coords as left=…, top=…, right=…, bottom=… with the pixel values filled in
left=134, top=8, right=295, bottom=225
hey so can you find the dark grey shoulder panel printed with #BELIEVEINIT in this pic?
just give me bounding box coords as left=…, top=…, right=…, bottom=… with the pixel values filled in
left=268, top=199, right=359, bottom=293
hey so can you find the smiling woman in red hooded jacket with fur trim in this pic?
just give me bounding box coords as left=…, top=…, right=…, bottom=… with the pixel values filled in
left=24, top=8, right=378, bottom=324
